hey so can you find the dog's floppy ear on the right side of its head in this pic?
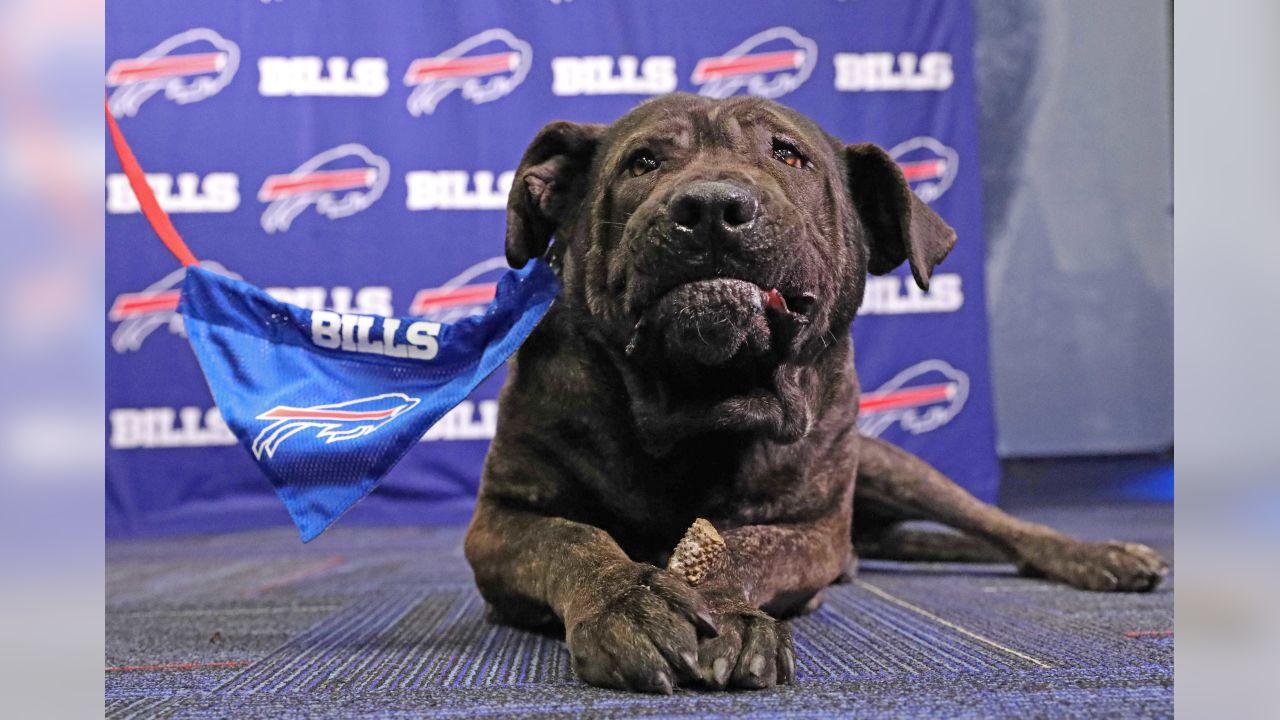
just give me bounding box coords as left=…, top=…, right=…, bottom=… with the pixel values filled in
left=845, top=142, right=956, bottom=290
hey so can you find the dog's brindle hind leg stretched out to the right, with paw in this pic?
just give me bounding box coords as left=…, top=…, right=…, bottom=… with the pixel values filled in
left=855, top=437, right=1167, bottom=592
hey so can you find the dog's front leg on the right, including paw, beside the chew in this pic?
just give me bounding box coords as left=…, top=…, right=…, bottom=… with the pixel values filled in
left=698, top=502, right=851, bottom=688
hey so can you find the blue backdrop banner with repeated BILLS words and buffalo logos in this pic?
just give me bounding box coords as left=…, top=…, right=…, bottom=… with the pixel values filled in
left=105, top=0, right=998, bottom=536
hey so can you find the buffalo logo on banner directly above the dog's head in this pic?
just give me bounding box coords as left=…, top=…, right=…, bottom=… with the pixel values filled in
left=690, top=27, right=818, bottom=97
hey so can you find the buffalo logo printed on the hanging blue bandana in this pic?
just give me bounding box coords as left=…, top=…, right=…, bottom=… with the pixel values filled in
left=252, top=392, right=420, bottom=460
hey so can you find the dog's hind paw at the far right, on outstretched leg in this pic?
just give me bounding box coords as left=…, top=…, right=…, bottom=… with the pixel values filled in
left=1019, top=541, right=1169, bottom=592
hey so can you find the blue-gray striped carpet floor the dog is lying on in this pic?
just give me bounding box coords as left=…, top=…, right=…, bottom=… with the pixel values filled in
left=106, top=505, right=1174, bottom=719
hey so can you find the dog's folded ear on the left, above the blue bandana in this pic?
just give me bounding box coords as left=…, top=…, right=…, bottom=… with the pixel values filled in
left=507, top=120, right=605, bottom=268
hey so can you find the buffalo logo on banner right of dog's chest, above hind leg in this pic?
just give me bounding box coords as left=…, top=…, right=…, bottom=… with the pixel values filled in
left=858, top=360, right=969, bottom=437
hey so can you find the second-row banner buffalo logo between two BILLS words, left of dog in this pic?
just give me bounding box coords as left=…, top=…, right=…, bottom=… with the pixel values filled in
left=257, top=142, right=390, bottom=233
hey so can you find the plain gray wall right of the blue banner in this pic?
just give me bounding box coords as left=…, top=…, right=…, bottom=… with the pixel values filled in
left=975, top=0, right=1174, bottom=456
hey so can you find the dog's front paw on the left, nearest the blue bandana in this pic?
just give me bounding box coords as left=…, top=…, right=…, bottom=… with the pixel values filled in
left=564, top=564, right=716, bottom=694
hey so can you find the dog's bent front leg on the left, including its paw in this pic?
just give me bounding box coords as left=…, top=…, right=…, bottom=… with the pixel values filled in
left=465, top=498, right=716, bottom=693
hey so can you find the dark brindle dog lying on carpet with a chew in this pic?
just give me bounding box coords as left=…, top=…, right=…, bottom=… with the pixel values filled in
left=465, top=95, right=1167, bottom=693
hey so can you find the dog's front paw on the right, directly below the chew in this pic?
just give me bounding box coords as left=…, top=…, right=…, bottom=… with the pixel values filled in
left=698, top=594, right=796, bottom=689
